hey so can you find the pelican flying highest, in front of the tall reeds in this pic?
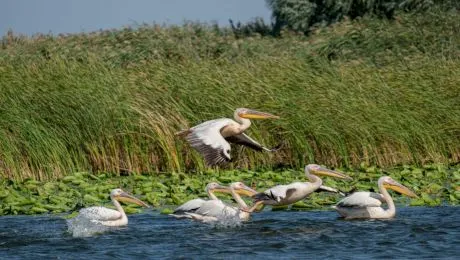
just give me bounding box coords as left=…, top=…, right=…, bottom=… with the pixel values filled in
left=176, top=108, right=280, bottom=166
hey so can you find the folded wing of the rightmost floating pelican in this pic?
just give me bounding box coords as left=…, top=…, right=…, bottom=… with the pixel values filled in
left=337, top=191, right=386, bottom=208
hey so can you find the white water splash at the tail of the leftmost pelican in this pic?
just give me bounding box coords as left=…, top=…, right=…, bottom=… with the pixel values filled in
left=67, top=215, right=110, bottom=237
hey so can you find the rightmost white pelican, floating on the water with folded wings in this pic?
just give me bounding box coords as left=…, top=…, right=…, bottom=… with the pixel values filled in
left=333, top=176, right=417, bottom=219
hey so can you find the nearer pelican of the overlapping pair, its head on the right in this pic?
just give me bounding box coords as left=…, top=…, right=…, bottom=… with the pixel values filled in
left=180, top=182, right=257, bottom=223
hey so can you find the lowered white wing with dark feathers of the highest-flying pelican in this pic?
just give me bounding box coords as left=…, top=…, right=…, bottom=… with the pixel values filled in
left=187, top=118, right=234, bottom=166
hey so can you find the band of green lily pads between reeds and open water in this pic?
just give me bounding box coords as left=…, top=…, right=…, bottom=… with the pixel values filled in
left=0, top=164, right=460, bottom=216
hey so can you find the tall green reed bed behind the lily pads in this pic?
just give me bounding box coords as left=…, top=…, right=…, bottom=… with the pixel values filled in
left=0, top=8, right=460, bottom=181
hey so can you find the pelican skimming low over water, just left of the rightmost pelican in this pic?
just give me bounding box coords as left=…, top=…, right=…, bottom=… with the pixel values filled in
left=249, top=164, right=352, bottom=212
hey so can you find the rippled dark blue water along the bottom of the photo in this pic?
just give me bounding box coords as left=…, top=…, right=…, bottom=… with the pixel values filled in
left=0, top=207, right=460, bottom=259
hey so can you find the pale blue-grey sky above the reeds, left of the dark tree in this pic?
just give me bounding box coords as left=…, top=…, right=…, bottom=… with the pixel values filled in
left=0, top=0, right=271, bottom=35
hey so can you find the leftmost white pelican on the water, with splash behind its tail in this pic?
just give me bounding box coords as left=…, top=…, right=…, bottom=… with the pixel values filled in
left=78, top=189, right=149, bottom=227
